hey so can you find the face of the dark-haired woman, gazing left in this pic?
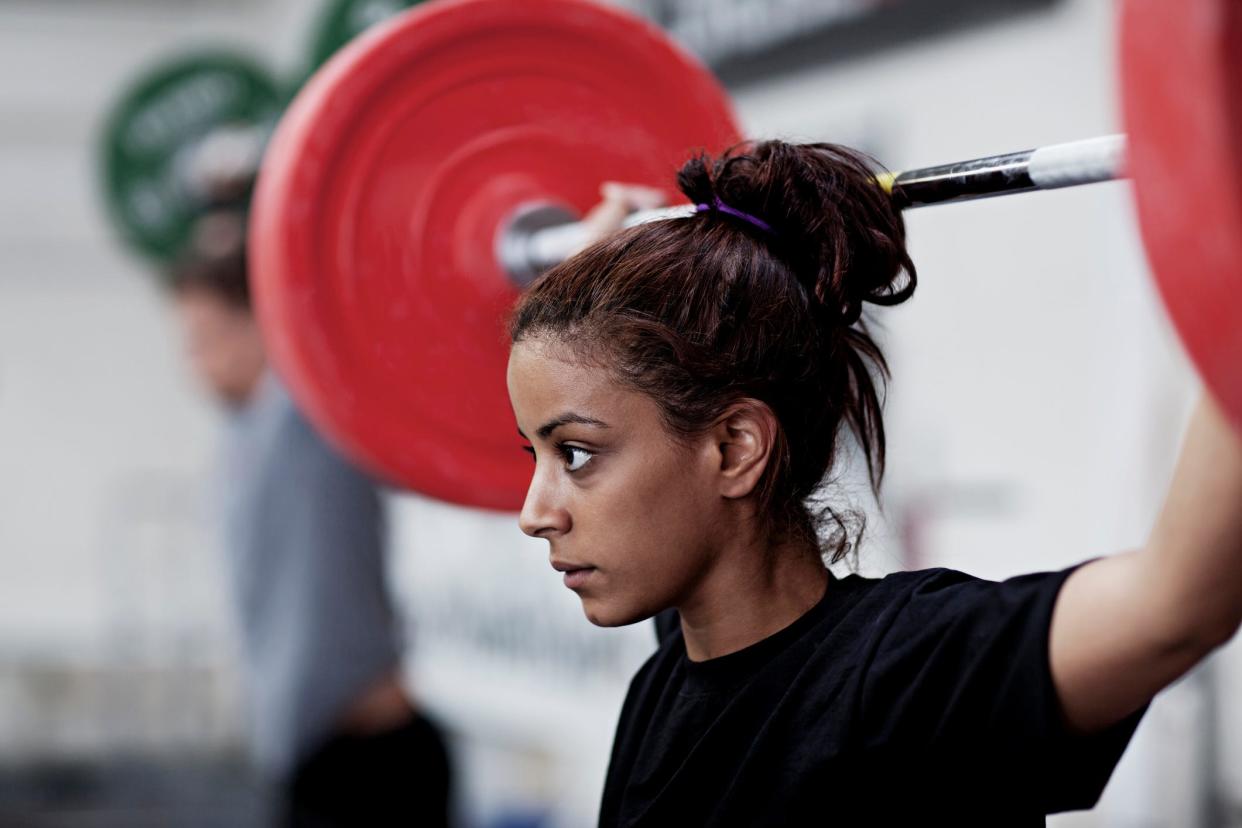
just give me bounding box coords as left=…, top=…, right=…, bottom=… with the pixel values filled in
left=508, top=339, right=728, bottom=627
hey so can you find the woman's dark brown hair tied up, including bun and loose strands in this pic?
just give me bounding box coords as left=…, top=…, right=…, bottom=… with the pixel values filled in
left=509, top=140, right=915, bottom=561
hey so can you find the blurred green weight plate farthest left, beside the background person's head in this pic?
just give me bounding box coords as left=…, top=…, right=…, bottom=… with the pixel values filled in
left=99, top=51, right=282, bottom=262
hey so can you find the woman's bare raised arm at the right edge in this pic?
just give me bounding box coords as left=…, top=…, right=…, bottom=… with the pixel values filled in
left=1048, top=394, right=1242, bottom=732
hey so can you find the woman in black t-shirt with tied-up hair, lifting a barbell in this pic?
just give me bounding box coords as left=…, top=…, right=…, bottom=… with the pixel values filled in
left=508, top=142, right=1242, bottom=826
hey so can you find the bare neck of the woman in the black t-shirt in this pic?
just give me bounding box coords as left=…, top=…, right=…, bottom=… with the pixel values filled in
left=678, top=533, right=830, bottom=662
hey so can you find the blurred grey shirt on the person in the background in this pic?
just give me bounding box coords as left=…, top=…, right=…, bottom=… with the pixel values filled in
left=222, top=376, right=399, bottom=780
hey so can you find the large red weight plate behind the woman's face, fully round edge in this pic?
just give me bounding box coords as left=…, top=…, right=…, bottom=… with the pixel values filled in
left=251, top=0, right=739, bottom=509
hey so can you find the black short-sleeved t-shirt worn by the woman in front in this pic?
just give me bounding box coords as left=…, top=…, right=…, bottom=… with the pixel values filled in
left=600, top=569, right=1145, bottom=827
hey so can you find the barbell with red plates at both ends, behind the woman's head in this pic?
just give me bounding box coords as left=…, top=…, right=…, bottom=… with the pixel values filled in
left=250, top=0, right=1242, bottom=509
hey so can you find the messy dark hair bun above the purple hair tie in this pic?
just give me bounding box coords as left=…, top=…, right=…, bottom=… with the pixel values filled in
left=677, top=140, right=917, bottom=325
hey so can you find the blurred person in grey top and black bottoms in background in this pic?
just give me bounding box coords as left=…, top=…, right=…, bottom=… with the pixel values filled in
left=170, top=214, right=451, bottom=827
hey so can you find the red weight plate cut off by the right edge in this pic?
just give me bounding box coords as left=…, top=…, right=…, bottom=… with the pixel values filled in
left=1122, top=0, right=1242, bottom=427
